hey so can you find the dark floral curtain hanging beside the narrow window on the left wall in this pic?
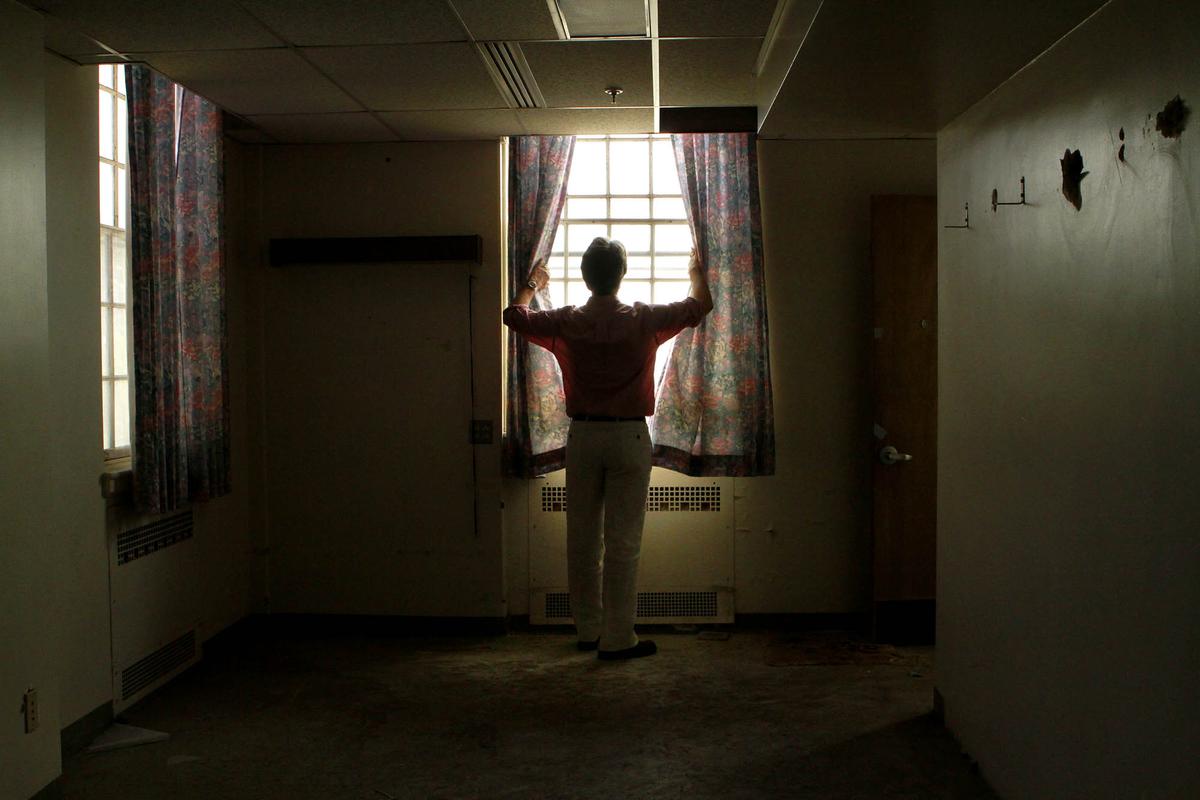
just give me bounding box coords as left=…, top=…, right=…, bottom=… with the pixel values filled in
left=126, top=65, right=229, bottom=513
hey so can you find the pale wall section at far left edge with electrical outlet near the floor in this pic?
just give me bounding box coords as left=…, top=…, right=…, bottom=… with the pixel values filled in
left=0, top=0, right=62, bottom=799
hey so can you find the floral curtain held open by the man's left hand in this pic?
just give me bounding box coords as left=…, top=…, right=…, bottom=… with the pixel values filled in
left=504, top=136, right=575, bottom=477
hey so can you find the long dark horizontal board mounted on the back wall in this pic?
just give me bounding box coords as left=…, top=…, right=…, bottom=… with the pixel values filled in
left=269, top=234, right=484, bottom=266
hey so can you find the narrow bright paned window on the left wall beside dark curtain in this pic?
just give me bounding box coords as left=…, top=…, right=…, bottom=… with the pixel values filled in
left=100, top=64, right=131, bottom=458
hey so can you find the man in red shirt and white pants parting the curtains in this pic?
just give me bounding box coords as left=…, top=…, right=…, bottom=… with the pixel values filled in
left=504, top=236, right=713, bottom=660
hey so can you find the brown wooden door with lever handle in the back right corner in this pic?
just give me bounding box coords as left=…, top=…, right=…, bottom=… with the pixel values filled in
left=871, top=196, right=937, bottom=643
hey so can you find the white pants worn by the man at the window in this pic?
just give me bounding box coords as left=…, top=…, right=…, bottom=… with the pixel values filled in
left=566, top=421, right=650, bottom=650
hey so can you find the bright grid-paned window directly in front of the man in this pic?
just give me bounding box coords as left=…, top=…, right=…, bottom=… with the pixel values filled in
left=546, top=134, right=692, bottom=383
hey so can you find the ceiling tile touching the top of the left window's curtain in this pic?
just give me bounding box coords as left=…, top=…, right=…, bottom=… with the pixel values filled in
left=138, top=49, right=362, bottom=115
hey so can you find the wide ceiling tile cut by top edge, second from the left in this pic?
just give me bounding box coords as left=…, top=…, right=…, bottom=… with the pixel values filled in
left=242, top=0, right=467, bottom=46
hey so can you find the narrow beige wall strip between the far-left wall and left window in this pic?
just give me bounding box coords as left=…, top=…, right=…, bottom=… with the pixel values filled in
left=43, top=54, right=113, bottom=726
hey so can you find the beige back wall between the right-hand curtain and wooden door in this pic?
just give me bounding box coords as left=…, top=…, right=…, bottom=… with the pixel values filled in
left=734, top=140, right=936, bottom=613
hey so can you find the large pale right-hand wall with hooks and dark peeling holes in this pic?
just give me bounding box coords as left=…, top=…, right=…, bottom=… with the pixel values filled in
left=937, top=0, right=1200, bottom=799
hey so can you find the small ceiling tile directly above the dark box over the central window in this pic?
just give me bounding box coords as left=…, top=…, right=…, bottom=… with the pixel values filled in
left=659, top=38, right=762, bottom=106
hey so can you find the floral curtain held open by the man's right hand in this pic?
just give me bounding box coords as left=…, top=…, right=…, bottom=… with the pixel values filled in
left=652, top=133, right=775, bottom=476
